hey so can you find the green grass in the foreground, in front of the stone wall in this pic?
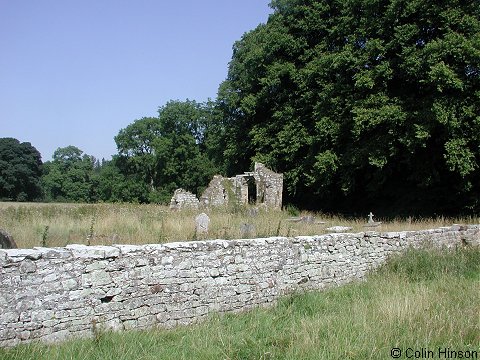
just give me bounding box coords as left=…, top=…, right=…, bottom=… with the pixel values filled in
left=0, top=248, right=480, bottom=360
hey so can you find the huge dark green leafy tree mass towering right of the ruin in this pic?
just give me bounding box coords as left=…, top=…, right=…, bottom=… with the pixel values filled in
left=217, top=0, right=480, bottom=213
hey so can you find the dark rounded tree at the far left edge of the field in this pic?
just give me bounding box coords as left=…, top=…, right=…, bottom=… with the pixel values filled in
left=0, top=138, right=42, bottom=201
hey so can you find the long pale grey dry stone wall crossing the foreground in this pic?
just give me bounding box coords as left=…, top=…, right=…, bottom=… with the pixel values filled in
left=0, top=225, right=480, bottom=346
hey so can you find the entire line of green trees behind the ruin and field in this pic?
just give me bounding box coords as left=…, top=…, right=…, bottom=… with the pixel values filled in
left=0, top=0, right=480, bottom=215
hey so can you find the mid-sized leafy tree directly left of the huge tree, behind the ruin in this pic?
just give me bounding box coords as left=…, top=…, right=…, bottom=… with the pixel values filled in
left=114, top=100, right=215, bottom=203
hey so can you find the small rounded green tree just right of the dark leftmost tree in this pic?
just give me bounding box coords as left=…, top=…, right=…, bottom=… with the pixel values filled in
left=42, top=145, right=98, bottom=202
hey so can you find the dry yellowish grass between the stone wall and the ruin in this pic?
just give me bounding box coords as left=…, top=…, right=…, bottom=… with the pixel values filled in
left=0, top=202, right=480, bottom=248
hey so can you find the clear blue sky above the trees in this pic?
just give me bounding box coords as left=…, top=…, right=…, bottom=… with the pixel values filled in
left=0, top=0, right=272, bottom=161
